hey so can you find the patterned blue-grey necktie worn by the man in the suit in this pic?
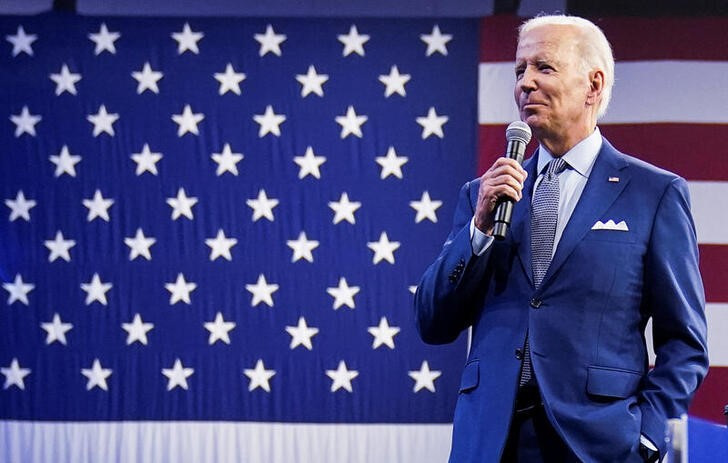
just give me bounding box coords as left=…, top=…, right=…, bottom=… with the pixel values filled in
left=519, top=158, right=566, bottom=386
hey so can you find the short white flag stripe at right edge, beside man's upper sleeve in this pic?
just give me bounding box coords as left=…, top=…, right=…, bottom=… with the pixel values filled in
left=688, top=181, right=728, bottom=246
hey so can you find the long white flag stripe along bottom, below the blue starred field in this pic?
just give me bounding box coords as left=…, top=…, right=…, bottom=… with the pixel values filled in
left=0, top=421, right=452, bottom=463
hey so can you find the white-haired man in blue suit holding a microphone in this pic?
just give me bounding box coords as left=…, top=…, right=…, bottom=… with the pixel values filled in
left=415, top=16, right=707, bottom=463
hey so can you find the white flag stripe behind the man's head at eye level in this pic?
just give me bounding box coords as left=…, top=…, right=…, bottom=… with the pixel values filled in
left=478, top=61, right=728, bottom=124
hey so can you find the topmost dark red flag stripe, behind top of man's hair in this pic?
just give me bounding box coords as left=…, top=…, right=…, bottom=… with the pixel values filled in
left=480, top=15, right=728, bottom=61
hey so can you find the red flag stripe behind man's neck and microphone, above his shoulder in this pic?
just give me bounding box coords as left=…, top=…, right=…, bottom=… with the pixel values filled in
left=478, top=124, right=728, bottom=183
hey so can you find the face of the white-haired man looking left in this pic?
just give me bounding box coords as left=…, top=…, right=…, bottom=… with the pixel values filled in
left=514, top=26, right=590, bottom=138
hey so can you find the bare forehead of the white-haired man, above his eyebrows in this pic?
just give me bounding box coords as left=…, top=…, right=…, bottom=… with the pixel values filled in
left=516, top=25, right=579, bottom=62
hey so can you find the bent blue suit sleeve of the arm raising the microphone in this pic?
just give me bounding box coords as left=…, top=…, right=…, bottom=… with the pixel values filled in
left=414, top=180, right=492, bottom=344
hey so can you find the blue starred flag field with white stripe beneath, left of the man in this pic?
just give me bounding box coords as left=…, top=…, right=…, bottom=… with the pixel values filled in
left=0, top=14, right=478, bottom=461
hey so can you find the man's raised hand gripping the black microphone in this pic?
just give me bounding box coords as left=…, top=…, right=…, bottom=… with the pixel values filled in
left=474, top=157, right=528, bottom=236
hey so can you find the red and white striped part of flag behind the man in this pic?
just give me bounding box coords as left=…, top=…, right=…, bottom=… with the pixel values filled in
left=478, top=16, right=728, bottom=423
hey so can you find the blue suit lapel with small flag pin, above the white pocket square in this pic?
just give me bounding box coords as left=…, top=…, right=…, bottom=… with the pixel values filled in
left=540, top=139, right=630, bottom=288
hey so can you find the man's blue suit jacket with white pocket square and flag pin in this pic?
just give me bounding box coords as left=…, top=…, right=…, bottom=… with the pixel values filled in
left=415, top=140, right=708, bottom=463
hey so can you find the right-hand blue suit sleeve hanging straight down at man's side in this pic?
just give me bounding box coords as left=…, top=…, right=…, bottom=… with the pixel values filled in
left=640, top=178, right=708, bottom=455
